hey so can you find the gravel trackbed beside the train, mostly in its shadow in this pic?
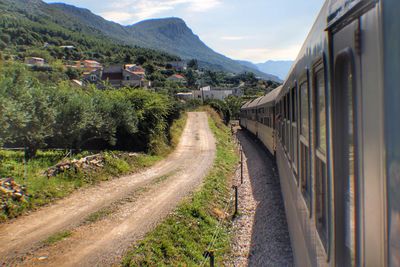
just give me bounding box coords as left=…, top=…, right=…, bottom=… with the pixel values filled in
left=231, top=130, right=293, bottom=267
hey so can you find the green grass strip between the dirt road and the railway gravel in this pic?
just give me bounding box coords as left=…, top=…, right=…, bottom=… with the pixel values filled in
left=122, top=108, right=238, bottom=266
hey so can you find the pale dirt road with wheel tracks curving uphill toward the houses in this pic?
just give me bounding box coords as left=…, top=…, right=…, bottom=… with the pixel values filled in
left=0, top=112, right=215, bottom=266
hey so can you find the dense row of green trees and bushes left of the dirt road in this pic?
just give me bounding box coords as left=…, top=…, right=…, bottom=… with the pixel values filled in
left=0, top=64, right=181, bottom=159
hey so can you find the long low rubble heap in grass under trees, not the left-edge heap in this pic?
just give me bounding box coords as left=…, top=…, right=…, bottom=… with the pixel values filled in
left=44, top=154, right=105, bottom=178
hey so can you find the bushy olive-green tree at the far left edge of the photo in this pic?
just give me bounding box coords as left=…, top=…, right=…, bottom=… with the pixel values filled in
left=0, top=64, right=55, bottom=157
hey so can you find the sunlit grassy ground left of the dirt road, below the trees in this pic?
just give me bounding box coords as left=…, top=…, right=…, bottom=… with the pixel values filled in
left=0, top=115, right=187, bottom=222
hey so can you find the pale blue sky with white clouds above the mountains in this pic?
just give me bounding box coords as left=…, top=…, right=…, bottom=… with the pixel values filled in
left=45, top=0, right=325, bottom=63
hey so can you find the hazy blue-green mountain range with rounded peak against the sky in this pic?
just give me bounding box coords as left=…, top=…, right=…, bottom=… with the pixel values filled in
left=0, top=0, right=281, bottom=81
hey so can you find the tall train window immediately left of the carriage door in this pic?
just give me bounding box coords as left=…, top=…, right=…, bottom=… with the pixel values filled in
left=314, top=65, right=328, bottom=249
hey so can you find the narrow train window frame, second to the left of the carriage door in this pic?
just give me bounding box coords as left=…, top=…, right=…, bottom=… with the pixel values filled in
left=298, top=70, right=313, bottom=213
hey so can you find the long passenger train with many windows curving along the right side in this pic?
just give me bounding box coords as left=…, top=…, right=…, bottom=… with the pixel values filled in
left=240, top=0, right=400, bottom=266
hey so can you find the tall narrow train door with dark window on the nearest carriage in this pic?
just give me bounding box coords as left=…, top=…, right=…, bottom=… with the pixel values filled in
left=332, top=20, right=361, bottom=266
